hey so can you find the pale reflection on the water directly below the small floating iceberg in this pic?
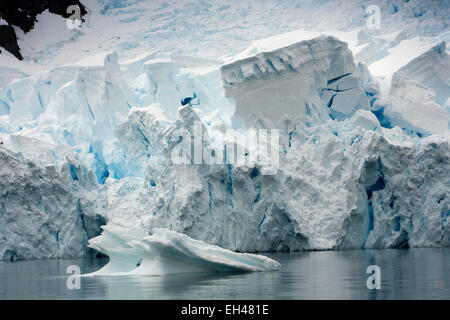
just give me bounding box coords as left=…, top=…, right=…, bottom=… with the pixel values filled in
left=83, top=272, right=274, bottom=299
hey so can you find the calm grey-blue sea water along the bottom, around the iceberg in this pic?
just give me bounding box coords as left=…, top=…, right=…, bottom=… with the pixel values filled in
left=0, top=248, right=450, bottom=300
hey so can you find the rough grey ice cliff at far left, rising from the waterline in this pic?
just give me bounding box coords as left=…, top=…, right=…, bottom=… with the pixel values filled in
left=0, top=148, right=106, bottom=261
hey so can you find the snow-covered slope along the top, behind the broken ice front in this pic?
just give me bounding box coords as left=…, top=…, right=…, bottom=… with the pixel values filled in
left=0, top=0, right=450, bottom=82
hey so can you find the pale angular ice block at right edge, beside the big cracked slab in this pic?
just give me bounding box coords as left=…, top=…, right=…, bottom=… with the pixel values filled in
left=384, top=42, right=450, bottom=135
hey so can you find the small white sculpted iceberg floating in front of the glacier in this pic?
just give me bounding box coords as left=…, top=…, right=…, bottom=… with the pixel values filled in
left=86, top=225, right=281, bottom=276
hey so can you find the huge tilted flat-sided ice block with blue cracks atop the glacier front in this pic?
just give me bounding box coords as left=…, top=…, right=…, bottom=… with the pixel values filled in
left=221, top=37, right=369, bottom=128
